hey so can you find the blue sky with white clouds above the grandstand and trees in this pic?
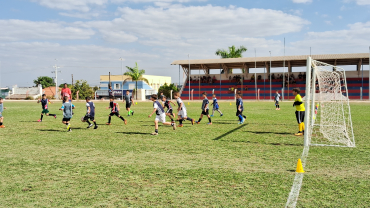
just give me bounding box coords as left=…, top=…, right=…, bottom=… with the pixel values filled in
left=0, top=0, right=370, bottom=87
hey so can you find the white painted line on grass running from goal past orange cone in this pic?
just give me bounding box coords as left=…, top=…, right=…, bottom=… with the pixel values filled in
left=285, top=146, right=309, bottom=208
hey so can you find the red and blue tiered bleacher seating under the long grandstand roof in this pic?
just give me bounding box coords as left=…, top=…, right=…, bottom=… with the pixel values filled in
left=181, top=78, right=369, bottom=100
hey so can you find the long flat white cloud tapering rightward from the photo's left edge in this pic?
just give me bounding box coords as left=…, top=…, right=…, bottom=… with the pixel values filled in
left=0, top=19, right=95, bottom=41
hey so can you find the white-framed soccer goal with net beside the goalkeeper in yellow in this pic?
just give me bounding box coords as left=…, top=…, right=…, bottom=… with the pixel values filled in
left=304, top=57, right=355, bottom=147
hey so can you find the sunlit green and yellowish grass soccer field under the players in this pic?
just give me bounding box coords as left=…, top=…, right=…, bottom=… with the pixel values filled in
left=0, top=101, right=370, bottom=207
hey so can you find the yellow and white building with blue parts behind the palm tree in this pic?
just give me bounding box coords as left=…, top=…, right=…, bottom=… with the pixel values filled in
left=96, top=75, right=171, bottom=100
